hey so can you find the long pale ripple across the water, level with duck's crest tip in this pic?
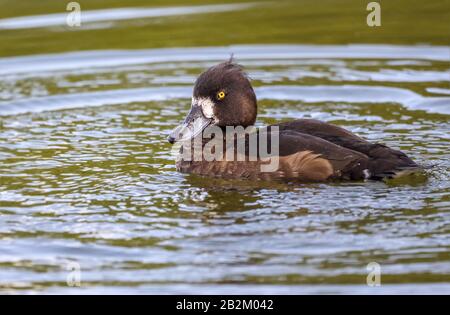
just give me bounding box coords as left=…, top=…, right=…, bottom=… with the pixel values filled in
left=0, top=45, right=450, bottom=75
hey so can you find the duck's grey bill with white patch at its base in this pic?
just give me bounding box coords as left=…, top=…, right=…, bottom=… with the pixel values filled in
left=167, top=106, right=212, bottom=144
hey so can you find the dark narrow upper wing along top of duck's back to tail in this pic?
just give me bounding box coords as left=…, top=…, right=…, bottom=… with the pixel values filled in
left=277, top=119, right=418, bottom=170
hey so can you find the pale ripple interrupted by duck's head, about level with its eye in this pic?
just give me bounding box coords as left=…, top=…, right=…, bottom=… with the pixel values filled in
left=0, top=85, right=450, bottom=115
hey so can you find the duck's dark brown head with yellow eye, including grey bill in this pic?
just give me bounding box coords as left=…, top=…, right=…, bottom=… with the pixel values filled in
left=167, top=60, right=257, bottom=143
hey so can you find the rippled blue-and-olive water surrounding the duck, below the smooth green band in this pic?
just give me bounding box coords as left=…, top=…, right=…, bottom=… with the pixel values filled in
left=0, top=0, right=450, bottom=294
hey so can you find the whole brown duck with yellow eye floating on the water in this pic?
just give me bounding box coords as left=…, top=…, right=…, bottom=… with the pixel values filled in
left=167, top=58, right=421, bottom=182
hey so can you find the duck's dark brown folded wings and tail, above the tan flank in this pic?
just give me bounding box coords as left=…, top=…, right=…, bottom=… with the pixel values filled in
left=278, top=119, right=418, bottom=179
